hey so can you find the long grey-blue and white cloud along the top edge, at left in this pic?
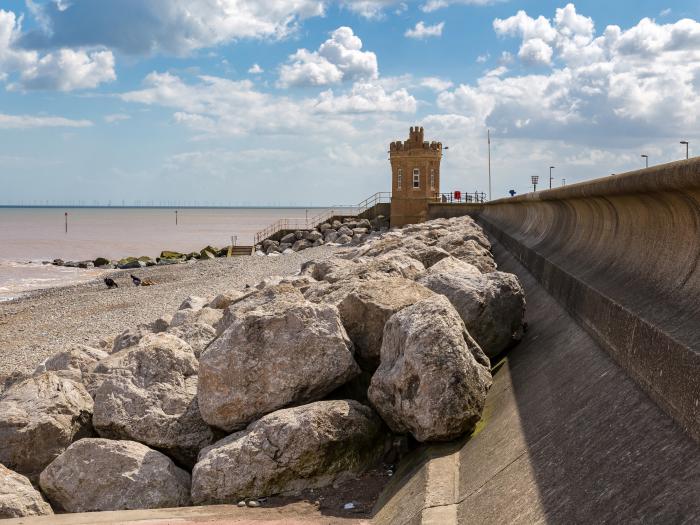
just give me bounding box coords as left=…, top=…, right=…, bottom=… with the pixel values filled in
left=20, top=0, right=326, bottom=55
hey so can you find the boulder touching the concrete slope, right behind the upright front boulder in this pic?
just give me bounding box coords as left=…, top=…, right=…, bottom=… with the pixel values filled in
left=418, top=268, right=525, bottom=357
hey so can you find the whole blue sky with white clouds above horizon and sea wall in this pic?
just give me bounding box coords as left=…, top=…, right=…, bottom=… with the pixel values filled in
left=0, top=0, right=700, bottom=206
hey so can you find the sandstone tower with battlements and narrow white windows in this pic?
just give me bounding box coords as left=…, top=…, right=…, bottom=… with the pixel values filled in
left=389, top=126, right=442, bottom=226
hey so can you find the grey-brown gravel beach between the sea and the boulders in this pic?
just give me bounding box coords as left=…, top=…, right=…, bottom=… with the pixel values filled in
left=0, top=246, right=334, bottom=384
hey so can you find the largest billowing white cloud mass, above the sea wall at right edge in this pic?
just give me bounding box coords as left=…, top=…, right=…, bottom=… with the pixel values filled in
left=437, top=4, right=700, bottom=145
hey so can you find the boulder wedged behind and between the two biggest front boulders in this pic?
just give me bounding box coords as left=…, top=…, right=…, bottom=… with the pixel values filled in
left=338, top=277, right=434, bottom=371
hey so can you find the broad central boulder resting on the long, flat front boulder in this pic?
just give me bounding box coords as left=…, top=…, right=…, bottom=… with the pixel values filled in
left=198, top=284, right=359, bottom=431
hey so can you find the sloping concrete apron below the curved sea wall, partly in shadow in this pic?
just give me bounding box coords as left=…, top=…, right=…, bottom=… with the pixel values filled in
left=374, top=239, right=700, bottom=525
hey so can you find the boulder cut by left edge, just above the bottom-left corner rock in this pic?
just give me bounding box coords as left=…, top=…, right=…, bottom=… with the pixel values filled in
left=0, top=372, right=93, bottom=478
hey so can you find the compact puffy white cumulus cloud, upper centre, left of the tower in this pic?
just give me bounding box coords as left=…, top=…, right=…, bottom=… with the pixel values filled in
left=278, top=26, right=379, bottom=87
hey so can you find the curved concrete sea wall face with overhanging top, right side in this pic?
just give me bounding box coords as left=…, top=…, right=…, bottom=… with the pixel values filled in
left=479, top=158, right=700, bottom=441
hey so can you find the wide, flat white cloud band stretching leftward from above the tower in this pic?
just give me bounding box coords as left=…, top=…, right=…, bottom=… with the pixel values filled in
left=121, top=73, right=417, bottom=137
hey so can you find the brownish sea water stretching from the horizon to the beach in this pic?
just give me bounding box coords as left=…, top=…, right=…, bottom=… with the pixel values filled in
left=0, top=207, right=325, bottom=301
